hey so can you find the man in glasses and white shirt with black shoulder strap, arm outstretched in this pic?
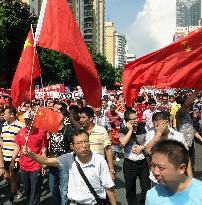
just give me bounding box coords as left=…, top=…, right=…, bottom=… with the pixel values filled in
left=23, top=129, right=116, bottom=205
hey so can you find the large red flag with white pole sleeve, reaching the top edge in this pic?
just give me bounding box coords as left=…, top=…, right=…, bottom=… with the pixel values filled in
left=36, top=0, right=102, bottom=106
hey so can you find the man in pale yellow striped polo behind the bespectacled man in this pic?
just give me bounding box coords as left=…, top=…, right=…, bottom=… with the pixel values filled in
left=80, top=107, right=115, bottom=180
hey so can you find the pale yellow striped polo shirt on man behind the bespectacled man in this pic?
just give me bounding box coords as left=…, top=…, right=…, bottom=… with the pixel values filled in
left=89, top=125, right=111, bottom=156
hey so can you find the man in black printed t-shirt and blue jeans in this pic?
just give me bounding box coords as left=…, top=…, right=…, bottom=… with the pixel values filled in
left=48, top=103, right=74, bottom=205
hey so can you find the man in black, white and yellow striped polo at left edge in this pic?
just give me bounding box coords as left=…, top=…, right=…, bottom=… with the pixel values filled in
left=1, top=106, right=25, bottom=204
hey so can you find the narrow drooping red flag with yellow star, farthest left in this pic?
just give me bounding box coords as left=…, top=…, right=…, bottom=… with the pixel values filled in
left=11, top=30, right=41, bottom=107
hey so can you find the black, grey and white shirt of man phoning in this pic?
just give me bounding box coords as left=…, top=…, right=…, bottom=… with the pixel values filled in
left=119, top=126, right=146, bottom=161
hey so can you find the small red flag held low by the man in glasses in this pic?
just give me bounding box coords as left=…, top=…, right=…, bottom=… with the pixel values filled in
left=33, top=107, right=63, bottom=133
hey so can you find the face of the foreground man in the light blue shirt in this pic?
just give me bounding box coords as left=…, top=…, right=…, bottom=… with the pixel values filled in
left=151, top=153, right=186, bottom=187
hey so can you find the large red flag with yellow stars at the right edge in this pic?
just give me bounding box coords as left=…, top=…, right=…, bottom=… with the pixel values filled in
left=122, top=28, right=202, bottom=107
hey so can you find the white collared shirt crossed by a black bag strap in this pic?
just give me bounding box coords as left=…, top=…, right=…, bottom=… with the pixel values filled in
left=57, top=153, right=114, bottom=205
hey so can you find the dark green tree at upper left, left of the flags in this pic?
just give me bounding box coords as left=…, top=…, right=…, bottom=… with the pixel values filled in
left=0, top=0, right=35, bottom=83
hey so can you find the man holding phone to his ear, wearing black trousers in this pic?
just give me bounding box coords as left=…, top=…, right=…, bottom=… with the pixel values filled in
left=119, top=110, right=151, bottom=205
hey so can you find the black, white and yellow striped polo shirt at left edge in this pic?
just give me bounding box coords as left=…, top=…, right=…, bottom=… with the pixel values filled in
left=1, top=120, right=25, bottom=161
